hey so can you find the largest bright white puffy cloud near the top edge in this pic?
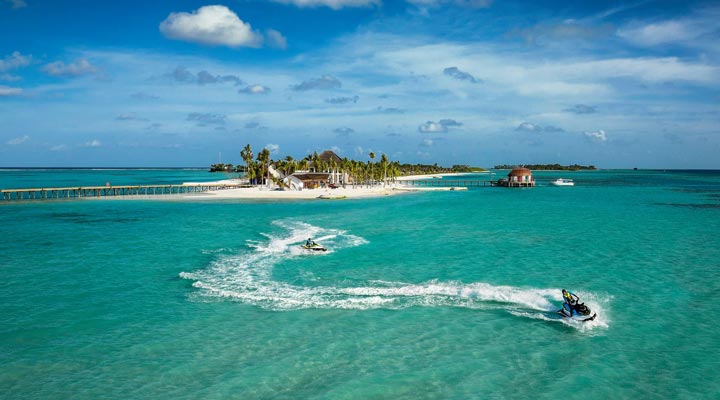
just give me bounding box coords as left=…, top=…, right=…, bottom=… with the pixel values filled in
left=160, top=5, right=262, bottom=47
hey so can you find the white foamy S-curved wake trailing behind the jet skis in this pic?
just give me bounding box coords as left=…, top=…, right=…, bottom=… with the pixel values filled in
left=180, top=221, right=609, bottom=329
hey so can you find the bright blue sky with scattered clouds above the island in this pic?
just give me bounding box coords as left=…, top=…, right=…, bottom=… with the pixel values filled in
left=0, top=0, right=720, bottom=168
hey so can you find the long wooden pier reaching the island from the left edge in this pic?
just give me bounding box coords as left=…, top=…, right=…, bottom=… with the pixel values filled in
left=0, top=184, right=244, bottom=201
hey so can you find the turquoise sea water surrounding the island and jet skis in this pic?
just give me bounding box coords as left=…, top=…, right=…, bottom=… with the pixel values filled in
left=0, top=171, right=720, bottom=399
